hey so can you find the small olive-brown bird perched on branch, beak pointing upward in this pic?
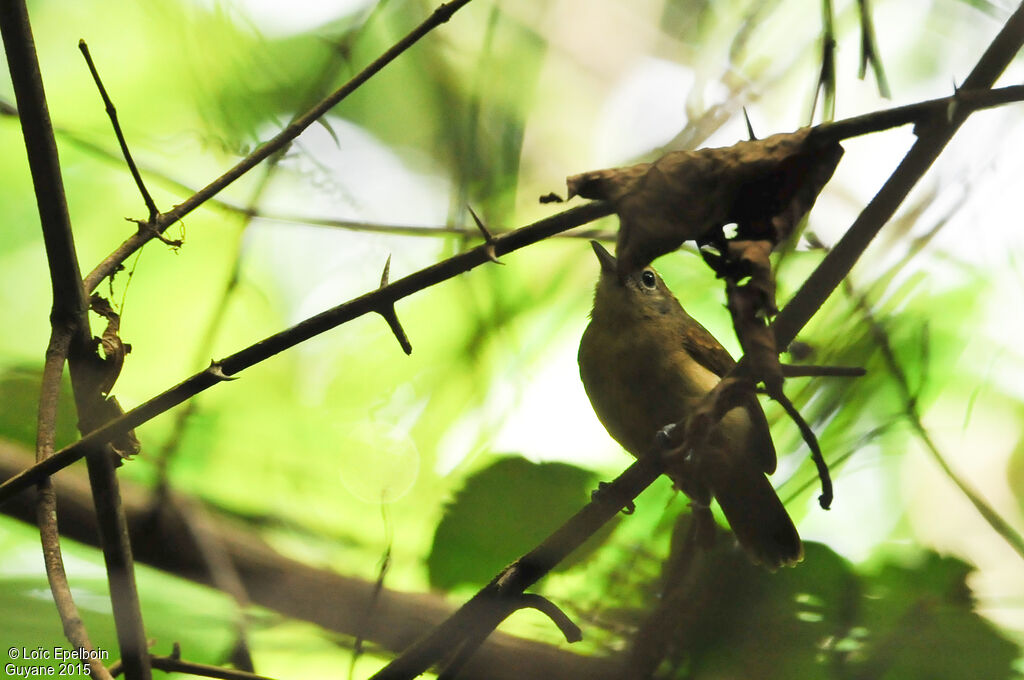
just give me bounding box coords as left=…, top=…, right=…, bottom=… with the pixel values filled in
left=579, top=241, right=804, bottom=569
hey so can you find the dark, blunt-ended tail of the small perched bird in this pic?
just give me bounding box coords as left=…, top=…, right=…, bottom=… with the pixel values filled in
left=705, top=464, right=804, bottom=569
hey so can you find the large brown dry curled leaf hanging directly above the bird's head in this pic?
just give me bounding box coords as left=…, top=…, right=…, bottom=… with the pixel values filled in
left=566, top=128, right=843, bottom=271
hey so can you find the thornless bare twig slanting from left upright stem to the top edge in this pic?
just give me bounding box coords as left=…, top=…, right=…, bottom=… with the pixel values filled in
left=85, top=0, right=470, bottom=291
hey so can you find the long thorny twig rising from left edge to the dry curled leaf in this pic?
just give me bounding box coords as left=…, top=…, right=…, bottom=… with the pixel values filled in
left=0, top=202, right=612, bottom=504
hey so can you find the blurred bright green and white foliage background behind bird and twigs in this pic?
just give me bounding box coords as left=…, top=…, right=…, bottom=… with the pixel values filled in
left=0, top=0, right=1024, bottom=678
